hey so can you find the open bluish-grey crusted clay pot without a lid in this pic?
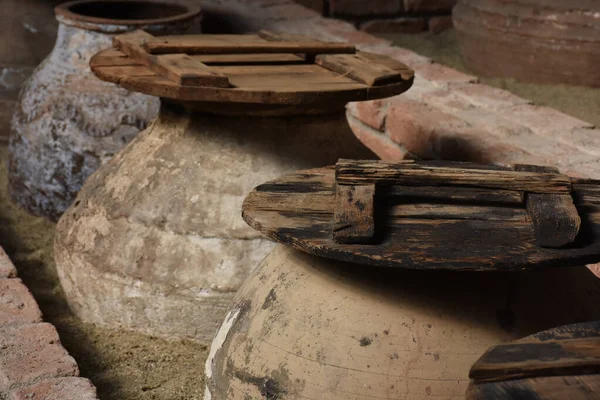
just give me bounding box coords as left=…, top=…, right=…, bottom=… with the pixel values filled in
left=9, top=0, right=200, bottom=219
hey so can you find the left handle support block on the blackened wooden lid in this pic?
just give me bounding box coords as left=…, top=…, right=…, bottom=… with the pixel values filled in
left=333, top=185, right=375, bottom=243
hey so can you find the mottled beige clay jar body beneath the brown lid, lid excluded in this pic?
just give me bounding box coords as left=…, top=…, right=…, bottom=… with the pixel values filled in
left=54, top=101, right=374, bottom=343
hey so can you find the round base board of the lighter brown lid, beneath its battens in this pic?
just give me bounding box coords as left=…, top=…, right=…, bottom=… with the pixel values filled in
left=90, top=50, right=413, bottom=105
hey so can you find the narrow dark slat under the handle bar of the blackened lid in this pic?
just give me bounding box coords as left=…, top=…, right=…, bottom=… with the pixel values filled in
left=385, top=185, right=525, bottom=205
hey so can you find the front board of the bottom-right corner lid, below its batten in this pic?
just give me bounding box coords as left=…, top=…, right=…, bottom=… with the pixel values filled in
left=466, top=374, right=600, bottom=400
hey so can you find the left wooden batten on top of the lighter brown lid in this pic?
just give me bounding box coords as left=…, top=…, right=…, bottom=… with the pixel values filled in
left=113, top=30, right=229, bottom=88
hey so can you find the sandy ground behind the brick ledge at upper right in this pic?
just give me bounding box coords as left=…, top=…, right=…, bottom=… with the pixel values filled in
left=379, top=30, right=600, bottom=126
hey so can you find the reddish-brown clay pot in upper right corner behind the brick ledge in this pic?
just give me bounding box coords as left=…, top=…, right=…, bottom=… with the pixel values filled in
left=453, top=0, right=600, bottom=86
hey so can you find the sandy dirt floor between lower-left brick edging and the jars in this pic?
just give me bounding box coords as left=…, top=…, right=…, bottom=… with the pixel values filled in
left=0, top=143, right=207, bottom=400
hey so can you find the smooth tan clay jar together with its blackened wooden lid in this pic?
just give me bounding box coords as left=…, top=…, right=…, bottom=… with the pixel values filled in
left=204, top=160, right=600, bottom=400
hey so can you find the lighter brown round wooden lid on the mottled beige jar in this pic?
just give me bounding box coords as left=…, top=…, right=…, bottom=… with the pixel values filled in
left=90, top=31, right=413, bottom=106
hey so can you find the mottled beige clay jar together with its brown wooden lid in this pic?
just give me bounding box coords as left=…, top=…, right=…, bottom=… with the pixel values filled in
left=54, top=35, right=412, bottom=343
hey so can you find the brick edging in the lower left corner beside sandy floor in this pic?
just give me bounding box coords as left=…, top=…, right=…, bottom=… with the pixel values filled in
left=0, top=247, right=97, bottom=400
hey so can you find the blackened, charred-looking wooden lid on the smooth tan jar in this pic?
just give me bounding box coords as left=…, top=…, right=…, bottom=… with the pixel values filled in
left=242, top=160, right=600, bottom=271
